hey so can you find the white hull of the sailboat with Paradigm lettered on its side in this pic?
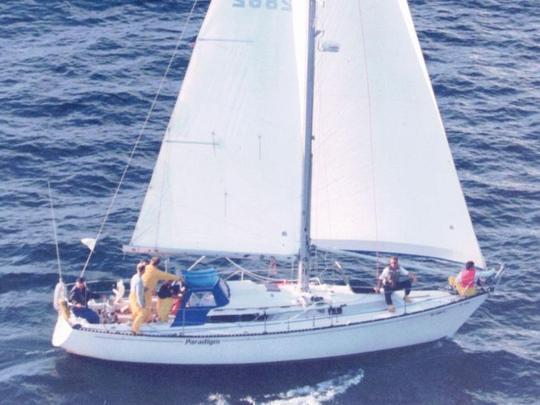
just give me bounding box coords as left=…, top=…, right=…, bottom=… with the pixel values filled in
left=53, top=294, right=487, bottom=365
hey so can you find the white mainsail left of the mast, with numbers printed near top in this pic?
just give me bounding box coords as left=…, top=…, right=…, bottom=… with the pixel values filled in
left=125, top=0, right=308, bottom=255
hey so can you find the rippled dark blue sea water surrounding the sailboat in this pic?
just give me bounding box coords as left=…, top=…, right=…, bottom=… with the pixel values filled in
left=0, top=0, right=540, bottom=404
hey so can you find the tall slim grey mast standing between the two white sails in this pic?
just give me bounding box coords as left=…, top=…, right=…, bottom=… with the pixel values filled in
left=298, top=0, right=317, bottom=290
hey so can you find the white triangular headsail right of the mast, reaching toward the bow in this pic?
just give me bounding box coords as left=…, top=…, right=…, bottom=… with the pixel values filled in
left=311, top=0, right=485, bottom=267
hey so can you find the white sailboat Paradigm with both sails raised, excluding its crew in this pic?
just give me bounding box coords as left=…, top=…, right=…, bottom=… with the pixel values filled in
left=52, top=0, right=501, bottom=365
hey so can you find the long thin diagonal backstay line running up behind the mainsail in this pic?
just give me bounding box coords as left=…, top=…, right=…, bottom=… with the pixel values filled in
left=81, top=0, right=199, bottom=277
